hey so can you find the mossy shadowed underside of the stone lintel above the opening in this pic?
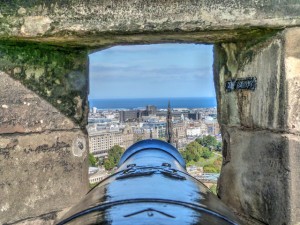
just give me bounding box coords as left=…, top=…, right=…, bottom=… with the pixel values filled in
left=0, top=27, right=283, bottom=48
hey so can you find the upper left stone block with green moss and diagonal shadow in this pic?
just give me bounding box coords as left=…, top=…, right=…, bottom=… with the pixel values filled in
left=0, top=43, right=88, bottom=128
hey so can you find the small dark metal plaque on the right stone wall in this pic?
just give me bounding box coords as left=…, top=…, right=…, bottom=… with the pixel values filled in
left=225, top=77, right=257, bottom=92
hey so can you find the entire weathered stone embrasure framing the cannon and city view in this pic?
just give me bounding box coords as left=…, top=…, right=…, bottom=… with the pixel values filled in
left=0, top=0, right=300, bottom=225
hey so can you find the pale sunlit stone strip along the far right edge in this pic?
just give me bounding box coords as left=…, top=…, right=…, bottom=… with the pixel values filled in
left=284, top=28, right=300, bottom=224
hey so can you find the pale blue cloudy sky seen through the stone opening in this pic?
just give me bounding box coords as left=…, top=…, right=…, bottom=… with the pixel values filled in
left=89, top=44, right=215, bottom=99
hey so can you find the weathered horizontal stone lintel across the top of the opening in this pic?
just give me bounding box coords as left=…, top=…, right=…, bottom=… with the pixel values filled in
left=0, top=0, right=300, bottom=46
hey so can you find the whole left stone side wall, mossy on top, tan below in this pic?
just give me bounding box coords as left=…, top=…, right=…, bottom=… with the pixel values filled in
left=0, top=44, right=88, bottom=224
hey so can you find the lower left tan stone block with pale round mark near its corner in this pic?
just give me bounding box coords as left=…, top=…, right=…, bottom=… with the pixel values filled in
left=0, top=130, right=88, bottom=223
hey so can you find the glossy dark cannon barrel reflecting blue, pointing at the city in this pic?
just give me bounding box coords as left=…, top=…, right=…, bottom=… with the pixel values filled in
left=58, top=140, right=240, bottom=225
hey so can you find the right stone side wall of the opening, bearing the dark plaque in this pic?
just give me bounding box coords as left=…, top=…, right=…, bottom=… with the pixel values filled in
left=214, top=28, right=300, bottom=224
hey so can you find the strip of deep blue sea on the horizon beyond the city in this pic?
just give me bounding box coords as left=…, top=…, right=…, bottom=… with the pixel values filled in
left=89, top=97, right=217, bottom=109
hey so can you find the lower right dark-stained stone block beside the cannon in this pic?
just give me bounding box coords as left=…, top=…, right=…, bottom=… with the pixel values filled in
left=218, top=128, right=294, bottom=225
